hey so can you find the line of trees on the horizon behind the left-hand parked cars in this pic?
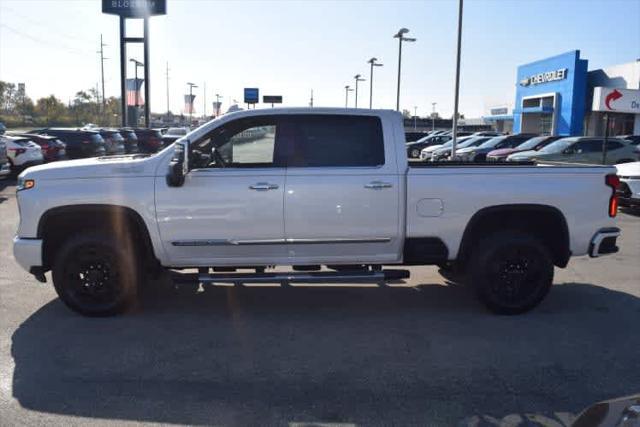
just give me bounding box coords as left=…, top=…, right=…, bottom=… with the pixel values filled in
left=0, top=80, right=120, bottom=128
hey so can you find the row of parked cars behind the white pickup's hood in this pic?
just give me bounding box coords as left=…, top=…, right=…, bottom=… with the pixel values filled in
left=0, top=123, right=188, bottom=177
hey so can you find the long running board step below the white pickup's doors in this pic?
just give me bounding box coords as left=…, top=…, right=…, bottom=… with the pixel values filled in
left=170, top=269, right=409, bottom=286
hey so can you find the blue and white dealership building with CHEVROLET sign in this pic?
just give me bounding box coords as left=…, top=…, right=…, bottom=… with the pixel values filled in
left=484, top=50, right=640, bottom=136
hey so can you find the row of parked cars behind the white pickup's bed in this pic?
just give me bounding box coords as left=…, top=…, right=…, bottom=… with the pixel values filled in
left=407, top=131, right=640, bottom=164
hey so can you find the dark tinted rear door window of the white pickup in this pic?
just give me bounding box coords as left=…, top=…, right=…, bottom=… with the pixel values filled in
left=287, top=115, right=384, bottom=167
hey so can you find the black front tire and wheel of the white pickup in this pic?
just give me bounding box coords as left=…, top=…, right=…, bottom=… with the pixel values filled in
left=52, top=232, right=141, bottom=317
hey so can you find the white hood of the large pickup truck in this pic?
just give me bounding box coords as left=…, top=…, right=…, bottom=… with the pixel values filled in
left=21, top=154, right=157, bottom=179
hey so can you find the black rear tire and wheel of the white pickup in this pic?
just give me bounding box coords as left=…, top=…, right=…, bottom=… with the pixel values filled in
left=469, top=231, right=553, bottom=314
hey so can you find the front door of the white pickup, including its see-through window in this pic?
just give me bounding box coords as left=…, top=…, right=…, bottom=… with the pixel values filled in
left=156, top=117, right=286, bottom=266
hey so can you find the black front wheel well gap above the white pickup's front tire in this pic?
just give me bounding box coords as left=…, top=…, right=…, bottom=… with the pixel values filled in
left=38, top=205, right=158, bottom=271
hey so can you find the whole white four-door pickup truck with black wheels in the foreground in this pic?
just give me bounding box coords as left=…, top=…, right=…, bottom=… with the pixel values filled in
left=14, top=108, right=619, bottom=316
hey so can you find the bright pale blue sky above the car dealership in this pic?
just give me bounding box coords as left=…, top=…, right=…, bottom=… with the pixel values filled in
left=0, top=0, right=640, bottom=117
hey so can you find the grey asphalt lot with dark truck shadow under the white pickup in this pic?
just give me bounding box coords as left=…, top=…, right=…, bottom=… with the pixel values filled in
left=0, top=181, right=640, bottom=426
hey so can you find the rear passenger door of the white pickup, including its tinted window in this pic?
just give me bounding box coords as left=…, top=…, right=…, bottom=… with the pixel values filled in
left=284, top=114, right=402, bottom=264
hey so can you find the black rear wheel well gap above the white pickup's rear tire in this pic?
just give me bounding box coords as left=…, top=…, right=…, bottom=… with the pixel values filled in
left=458, top=204, right=571, bottom=267
